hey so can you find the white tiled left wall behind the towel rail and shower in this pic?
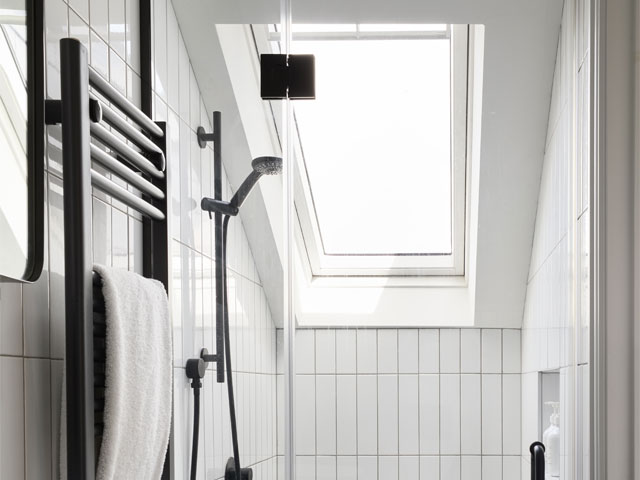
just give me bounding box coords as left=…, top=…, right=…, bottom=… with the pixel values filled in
left=0, top=0, right=276, bottom=480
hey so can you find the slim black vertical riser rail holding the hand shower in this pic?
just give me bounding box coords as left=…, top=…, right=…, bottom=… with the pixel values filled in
left=213, top=112, right=226, bottom=383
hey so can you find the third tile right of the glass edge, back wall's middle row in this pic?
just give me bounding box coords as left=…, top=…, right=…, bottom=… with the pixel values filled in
left=336, top=375, right=362, bottom=455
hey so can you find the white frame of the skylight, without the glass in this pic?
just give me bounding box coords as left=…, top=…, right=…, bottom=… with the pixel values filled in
left=288, top=25, right=470, bottom=277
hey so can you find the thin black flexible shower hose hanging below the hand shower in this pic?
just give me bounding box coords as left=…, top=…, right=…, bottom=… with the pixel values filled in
left=191, top=215, right=241, bottom=480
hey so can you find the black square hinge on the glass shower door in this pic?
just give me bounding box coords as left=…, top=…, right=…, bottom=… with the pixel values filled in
left=260, top=53, right=316, bottom=100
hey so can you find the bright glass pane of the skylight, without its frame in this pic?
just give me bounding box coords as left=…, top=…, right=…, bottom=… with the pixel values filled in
left=293, top=35, right=451, bottom=255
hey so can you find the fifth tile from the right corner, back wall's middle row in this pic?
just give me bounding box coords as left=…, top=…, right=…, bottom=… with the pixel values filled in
left=418, top=375, right=440, bottom=454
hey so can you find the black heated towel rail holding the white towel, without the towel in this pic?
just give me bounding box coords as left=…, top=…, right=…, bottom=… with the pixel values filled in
left=46, top=39, right=169, bottom=480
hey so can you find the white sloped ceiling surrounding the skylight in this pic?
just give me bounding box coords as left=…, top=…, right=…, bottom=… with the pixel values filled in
left=174, top=0, right=563, bottom=327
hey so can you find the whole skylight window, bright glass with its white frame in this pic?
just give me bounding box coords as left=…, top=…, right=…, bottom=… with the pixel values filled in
left=272, top=24, right=468, bottom=276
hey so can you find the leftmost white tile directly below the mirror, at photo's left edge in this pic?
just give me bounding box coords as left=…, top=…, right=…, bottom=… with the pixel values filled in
left=0, top=282, right=22, bottom=356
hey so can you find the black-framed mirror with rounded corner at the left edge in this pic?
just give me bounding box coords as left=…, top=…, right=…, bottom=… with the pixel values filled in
left=0, top=0, right=44, bottom=282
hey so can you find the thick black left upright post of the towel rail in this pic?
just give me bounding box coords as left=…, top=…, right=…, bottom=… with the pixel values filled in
left=60, top=38, right=95, bottom=480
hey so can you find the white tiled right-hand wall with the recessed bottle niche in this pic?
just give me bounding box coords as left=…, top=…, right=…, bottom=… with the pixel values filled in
left=522, top=0, right=590, bottom=479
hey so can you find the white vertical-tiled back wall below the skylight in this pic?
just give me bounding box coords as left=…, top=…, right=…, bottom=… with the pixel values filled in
left=288, top=329, right=521, bottom=480
